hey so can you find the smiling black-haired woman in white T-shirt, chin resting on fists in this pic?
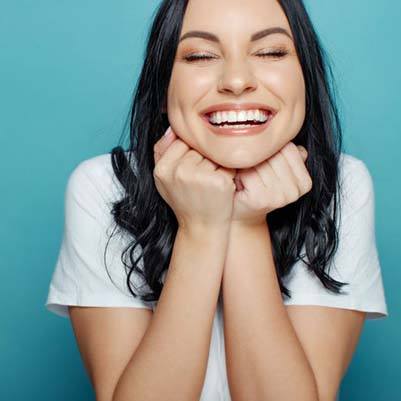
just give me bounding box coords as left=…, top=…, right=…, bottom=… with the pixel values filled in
left=46, top=0, right=388, bottom=401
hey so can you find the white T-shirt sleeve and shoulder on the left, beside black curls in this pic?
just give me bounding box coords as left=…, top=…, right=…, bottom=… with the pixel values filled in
left=45, top=154, right=153, bottom=317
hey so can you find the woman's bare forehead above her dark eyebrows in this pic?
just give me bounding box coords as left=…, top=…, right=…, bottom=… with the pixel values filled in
left=182, top=0, right=290, bottom=40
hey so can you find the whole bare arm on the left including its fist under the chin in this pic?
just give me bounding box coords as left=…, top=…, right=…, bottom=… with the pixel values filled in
left=67, top=130, right=235, bottom=401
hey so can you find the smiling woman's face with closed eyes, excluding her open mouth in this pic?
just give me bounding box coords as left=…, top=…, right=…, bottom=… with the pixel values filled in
left=167, top=0, right=305, bottom=168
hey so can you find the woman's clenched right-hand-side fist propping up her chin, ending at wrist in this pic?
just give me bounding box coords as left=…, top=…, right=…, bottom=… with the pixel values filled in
left=232, top=142, right=312, bottom=224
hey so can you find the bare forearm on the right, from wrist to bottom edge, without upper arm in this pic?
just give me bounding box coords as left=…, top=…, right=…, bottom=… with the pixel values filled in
left=222, top=224, right=318, bottom=401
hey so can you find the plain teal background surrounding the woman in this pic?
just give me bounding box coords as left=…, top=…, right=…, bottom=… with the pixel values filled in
left=0, top=0, right=401, bottom=401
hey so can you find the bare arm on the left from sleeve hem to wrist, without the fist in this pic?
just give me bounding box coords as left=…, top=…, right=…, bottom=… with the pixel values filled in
left=69, top=222, right=228, bottom=401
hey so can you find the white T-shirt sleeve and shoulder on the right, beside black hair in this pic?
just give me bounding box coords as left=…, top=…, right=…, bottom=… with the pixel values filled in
left=283, top=154, right=388, bottom=319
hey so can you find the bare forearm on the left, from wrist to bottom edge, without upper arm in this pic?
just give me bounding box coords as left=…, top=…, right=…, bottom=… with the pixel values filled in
left=113, top=225, right=229, bottom=401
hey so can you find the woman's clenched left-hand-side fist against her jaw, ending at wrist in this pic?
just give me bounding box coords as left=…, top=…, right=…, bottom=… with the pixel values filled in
left=153, top=127, right=235, bottom=228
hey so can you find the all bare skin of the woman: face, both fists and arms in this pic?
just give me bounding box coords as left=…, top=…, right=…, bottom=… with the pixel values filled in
left=70, top=0, right=365, bottom=401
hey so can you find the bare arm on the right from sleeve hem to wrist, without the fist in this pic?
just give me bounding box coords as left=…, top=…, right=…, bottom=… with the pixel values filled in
left=223, top=224, right=365, bottom=401
